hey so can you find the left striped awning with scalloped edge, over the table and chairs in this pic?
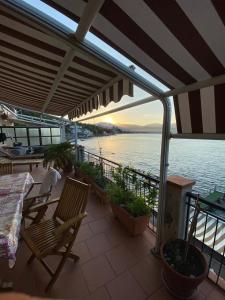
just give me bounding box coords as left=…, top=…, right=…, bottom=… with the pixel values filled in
left=0, top=4, right=133, bottom=117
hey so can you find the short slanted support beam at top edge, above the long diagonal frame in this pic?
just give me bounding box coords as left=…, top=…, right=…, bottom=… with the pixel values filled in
left=75, top=0, right=105, bottom=41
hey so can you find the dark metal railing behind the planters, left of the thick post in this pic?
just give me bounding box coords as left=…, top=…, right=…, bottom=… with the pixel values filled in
left=79, top=150, right=159, bottom=233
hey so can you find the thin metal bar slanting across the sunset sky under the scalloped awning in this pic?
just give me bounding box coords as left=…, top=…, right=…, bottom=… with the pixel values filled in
left=74, top=96, right=159, bottom=122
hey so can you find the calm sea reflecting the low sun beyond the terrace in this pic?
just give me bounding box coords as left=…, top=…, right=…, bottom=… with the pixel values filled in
left=79, top=134, right=225, bottom=193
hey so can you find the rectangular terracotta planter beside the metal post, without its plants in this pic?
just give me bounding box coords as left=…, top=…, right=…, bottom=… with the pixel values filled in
left=110, top=203, right=149, bottom=236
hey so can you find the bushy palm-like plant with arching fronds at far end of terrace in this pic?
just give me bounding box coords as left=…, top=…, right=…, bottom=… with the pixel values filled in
left=44, top=142, right=75, bottom=172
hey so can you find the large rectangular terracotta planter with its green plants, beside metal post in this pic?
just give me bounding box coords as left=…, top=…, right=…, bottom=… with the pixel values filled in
left=107, top=168, right=157, bottom=236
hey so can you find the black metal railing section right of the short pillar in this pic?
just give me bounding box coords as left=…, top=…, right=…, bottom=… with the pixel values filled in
left=185, top=193, right=225, bottom=289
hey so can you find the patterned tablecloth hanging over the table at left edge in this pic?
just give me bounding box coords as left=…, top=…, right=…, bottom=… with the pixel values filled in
left=0, top=172, right=34, bottom=268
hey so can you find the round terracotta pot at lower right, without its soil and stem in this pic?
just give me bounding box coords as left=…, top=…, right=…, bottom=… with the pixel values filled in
left=160, top=239, right=208, bottom=299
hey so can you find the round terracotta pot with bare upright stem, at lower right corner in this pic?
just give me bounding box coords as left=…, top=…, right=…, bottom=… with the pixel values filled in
left=160, top=199, right=208, bottom=299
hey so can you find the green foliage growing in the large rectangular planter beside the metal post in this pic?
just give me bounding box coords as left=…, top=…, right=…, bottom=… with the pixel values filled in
left=106, top=167, right=157, bottom=217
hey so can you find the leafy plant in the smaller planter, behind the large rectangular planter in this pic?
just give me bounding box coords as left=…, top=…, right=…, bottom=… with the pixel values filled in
left=76, top=162, right=109, bottom=204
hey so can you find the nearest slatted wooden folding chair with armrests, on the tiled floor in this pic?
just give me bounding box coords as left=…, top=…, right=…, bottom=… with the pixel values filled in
left=21, top=177, right=90, bottom=292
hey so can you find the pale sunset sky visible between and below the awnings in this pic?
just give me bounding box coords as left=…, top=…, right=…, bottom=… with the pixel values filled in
left=23, top=0, right=175, bottom=125
